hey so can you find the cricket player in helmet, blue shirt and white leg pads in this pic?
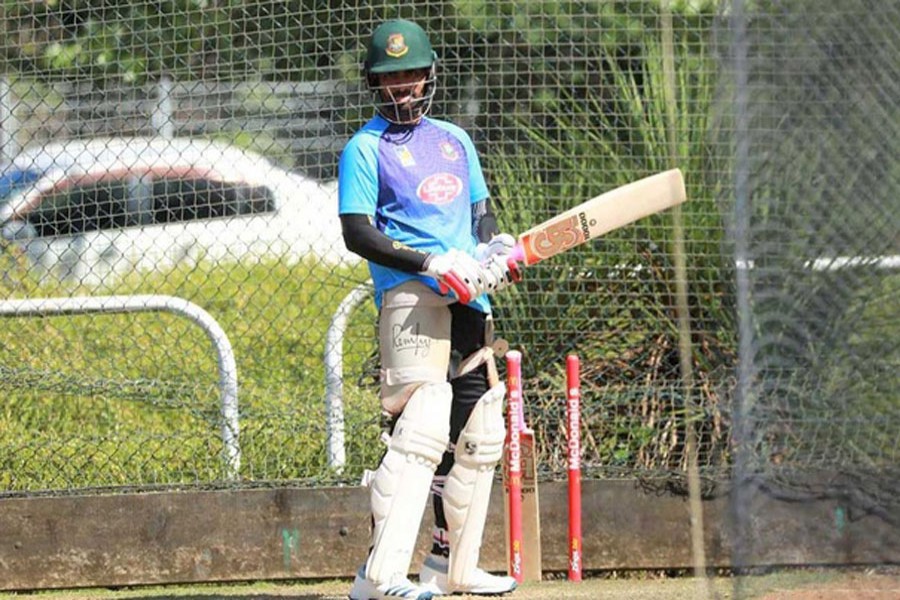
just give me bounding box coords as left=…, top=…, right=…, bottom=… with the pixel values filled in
left=338, top=20, right=517, bottom=600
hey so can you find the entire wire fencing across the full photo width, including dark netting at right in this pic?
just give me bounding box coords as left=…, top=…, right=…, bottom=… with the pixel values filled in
left=0, top=0, right=900, bottom=576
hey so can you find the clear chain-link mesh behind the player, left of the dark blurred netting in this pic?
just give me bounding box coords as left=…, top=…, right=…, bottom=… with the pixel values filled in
left=0, top=1, right=734, bottom=491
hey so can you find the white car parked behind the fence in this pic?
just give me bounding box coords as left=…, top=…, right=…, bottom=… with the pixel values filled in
left=0, top=138, right=358, bottom=284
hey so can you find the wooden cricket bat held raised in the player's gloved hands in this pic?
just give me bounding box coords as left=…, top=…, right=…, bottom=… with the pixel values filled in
left=446, top=169, right=687, bottom=304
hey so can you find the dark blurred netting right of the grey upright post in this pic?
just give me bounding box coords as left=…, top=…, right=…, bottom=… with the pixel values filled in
left=722, top=0, right=900, bottom=576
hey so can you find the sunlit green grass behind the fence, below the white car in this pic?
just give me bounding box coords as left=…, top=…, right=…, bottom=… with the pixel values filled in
left=0, top=261, right=379, bottom=490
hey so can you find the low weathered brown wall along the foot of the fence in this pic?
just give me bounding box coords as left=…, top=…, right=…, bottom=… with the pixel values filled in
left=0, top=480, right=900, bottom=590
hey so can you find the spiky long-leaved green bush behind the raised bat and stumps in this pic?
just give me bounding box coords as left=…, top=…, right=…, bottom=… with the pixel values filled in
left=488, top=29, right=736, bottom=478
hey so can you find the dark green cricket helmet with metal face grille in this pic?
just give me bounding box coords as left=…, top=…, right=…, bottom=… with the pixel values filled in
left=364, top=19, right=437, bottom=124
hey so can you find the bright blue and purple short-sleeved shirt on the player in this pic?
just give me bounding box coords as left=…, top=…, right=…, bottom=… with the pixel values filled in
left=338, top=115, right=491, bottom=313
